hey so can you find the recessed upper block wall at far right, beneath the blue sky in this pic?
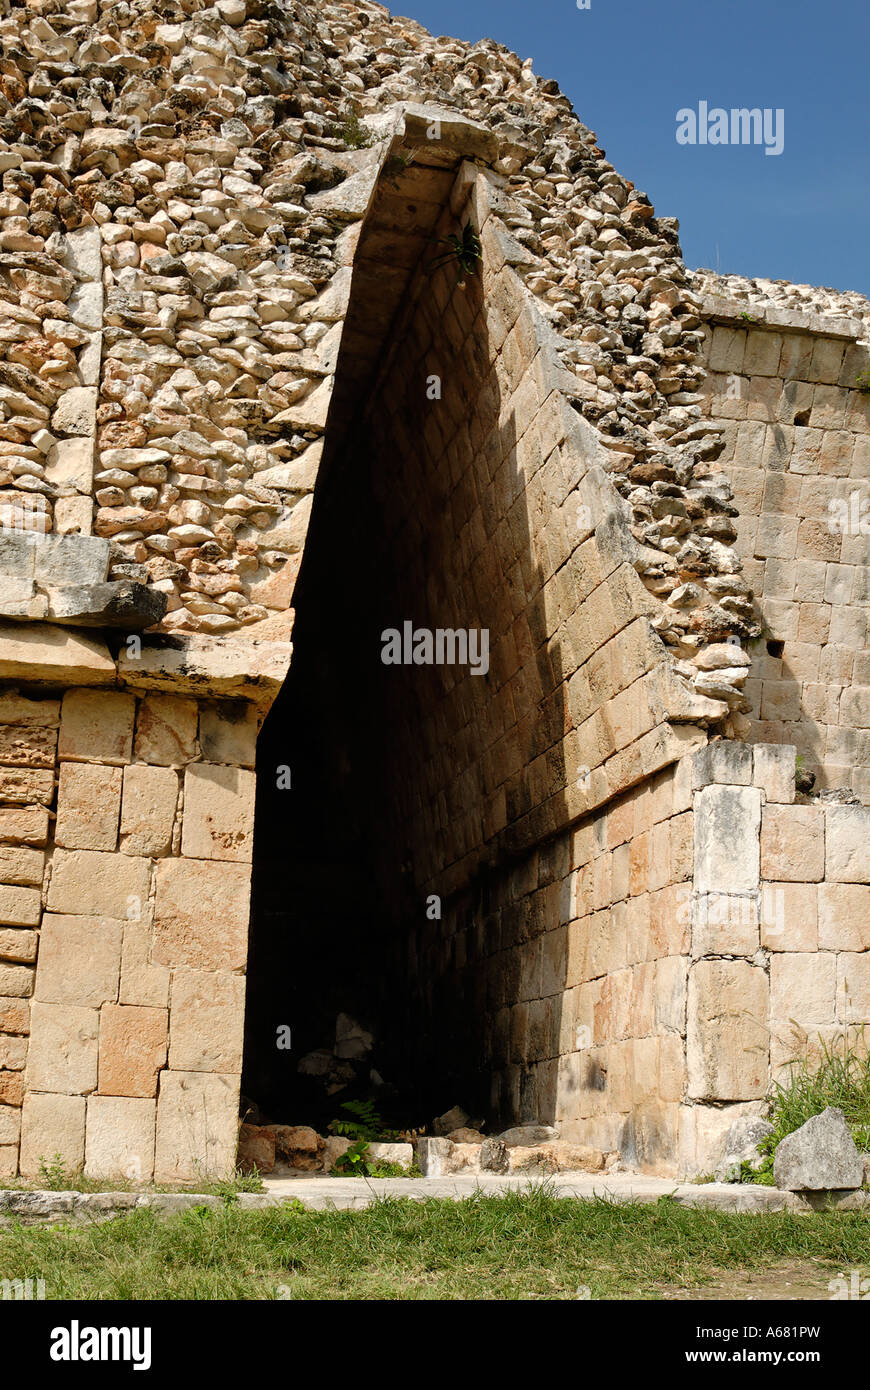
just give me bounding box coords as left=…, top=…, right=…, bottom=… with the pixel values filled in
left=702, top=299, right=870, bottom=802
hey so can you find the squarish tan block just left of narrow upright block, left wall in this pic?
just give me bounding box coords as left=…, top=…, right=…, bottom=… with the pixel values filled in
left=35, top=912, right=124, bottom=1008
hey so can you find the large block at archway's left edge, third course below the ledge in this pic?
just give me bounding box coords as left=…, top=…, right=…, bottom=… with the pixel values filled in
left=154, top=859, right=250, bottom=970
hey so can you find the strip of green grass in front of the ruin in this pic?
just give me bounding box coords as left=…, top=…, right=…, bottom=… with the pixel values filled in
left=0, top=1188, right=870, bottom=1300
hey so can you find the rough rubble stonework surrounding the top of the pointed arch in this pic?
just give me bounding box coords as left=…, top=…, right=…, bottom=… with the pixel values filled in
left=0, top=0, right=794, bottom=713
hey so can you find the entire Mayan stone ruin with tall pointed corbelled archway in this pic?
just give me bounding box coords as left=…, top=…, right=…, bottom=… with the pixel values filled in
left=0, top=0, right=870, bottom=1183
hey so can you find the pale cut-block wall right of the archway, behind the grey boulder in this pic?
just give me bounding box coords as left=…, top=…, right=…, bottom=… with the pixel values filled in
left=678, top=741, right=870, bottom=1172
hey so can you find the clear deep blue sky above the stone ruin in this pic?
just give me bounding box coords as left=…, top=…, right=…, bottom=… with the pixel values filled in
left=391, top=0, right=870, bottom=295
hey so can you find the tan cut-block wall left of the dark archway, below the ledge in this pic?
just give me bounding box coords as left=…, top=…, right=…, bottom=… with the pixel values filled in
left=0, top=677, right=258, bottom=1182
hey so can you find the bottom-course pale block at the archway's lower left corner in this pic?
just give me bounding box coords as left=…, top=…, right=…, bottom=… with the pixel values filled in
left=154, top=1072, right=239, bottom=1183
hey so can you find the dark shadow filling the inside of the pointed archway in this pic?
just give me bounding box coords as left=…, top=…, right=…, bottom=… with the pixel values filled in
left=242, top=208, right=570, bottom=1126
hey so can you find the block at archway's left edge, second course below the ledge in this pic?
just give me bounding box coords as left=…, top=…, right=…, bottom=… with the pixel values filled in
left=181, top=763, right=256, bottom=863
